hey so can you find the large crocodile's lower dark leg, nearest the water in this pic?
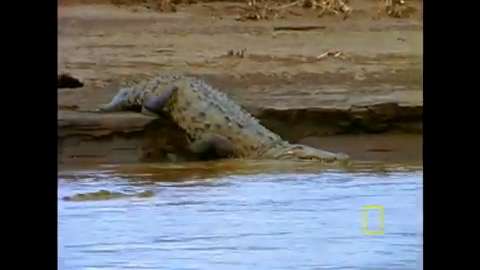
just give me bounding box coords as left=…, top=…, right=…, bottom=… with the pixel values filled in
left=190, top=134, right=234, bottom=158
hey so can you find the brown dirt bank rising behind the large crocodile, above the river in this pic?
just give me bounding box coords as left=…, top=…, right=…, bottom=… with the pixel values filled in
left=58, top=0, right=423, bottom=165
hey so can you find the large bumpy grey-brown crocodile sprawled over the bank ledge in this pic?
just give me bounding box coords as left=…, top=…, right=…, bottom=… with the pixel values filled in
left=95, top=74, right=349, bottom=163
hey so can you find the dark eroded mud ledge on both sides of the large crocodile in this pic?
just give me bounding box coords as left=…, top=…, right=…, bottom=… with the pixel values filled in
left=58, top=103, right=423, bottom=164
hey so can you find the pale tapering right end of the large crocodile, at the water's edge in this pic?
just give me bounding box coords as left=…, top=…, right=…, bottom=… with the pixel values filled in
left=267, top=144, right=349, bottom=163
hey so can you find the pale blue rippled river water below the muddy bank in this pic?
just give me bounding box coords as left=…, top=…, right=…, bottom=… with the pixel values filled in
left=58, top=162, right=423, bottom=270
